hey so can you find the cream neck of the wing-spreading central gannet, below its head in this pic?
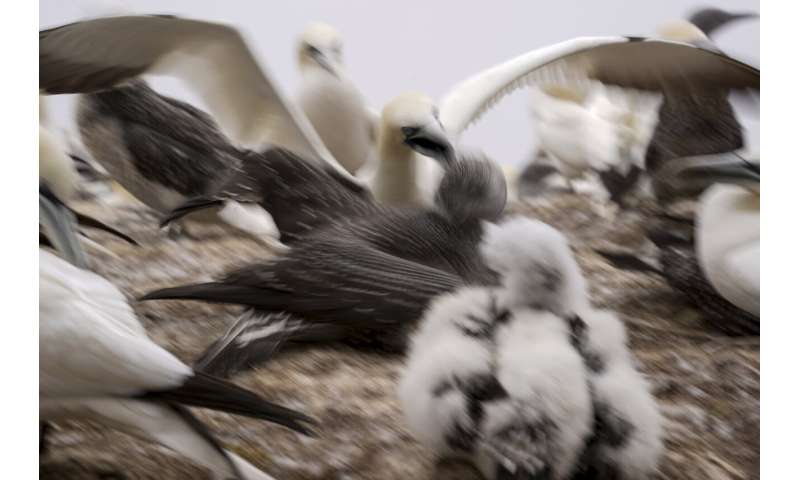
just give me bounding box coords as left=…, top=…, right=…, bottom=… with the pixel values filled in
left=373, top=139, right=422, bottom=205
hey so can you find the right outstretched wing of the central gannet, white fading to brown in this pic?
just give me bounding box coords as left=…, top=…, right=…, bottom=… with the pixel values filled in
left=439, top=37, right=760, bottom=135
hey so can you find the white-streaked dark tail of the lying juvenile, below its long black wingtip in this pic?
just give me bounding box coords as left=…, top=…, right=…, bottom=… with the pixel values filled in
left=194, top=310, right=346, bottom=377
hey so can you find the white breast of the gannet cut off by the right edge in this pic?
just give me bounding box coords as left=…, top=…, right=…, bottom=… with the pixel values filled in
left=695, top=185, right=761, bottom=316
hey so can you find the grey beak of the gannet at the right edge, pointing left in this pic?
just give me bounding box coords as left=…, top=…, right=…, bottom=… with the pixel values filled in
left=678, top=153, right=761, bottom=188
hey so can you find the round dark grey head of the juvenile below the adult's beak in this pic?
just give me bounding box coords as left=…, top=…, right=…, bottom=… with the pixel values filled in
left=435, top=152, right=507, bottom=223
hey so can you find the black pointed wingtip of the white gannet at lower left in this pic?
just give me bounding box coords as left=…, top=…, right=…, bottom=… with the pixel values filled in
left=140, top=372, right=314, bottom=435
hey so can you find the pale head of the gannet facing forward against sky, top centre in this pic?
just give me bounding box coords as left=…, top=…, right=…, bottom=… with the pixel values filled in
left=297, top=22, right=343, bottom=77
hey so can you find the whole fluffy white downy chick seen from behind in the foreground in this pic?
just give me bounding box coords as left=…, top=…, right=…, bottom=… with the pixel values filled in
left=399, top=217, right=662, bottom=479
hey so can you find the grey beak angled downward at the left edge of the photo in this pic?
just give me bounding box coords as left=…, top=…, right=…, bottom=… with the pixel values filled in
left=39, top=186, right=89, bottom=268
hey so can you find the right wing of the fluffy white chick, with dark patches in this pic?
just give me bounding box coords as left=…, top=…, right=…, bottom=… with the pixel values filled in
left=570, top=308, right=664, bottom=480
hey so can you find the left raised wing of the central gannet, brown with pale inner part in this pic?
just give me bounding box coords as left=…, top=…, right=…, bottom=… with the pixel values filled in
left=39, top=16, right=355, bottom=182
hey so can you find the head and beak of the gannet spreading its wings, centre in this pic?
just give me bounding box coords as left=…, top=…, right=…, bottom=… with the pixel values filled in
left=379, top=92, right=455, bottom=165
